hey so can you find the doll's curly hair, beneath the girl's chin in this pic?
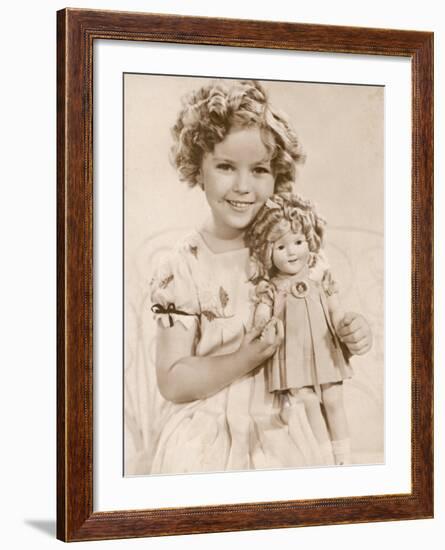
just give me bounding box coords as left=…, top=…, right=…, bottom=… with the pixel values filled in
left=245, top=193, right=326, bottom=282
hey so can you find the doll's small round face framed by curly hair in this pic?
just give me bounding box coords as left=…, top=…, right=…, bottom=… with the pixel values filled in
left=272, top=231, right=310, bottom=275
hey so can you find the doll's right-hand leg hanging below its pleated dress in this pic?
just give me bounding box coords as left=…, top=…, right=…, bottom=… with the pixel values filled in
left=321, top=382, right=351, bottom=465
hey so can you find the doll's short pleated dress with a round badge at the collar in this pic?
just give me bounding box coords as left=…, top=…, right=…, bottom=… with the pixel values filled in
left=257, top=269, right=352, bottom=392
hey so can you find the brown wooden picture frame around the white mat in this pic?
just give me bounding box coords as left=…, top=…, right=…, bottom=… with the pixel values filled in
left=57, top=9, right=433, bottom=541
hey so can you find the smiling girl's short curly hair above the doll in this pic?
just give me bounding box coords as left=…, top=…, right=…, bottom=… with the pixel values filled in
left=171, top=81, right=304, bottom=193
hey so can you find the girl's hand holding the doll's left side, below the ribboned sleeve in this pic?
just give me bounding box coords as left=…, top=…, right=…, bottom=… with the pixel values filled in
left=237, top=319, right=284, bottom=370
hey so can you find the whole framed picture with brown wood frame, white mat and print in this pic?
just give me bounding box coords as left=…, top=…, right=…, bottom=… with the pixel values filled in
left=57, top=9, right=433, bottom=541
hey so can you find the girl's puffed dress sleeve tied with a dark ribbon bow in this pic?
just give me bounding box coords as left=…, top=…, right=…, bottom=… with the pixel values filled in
left=150, top=251, right=200, bottom=329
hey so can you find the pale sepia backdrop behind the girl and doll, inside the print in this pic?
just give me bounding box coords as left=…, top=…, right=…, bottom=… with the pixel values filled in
left=124, top=74, right=384, bottom=475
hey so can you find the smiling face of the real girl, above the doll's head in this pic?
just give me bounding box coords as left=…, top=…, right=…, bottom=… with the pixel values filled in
left=200, top=127, right=275, bottom=239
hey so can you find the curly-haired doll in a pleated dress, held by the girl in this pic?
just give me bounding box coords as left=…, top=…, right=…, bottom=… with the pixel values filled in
left=246, top=193, right=352, bottom=464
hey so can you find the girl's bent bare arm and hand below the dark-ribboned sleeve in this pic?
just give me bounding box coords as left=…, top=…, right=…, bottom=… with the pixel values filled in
left=156, top=323, right=280, bottom=403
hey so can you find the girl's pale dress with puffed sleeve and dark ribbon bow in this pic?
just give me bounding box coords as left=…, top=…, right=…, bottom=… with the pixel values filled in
left=151, top=232, right=324, bottom=473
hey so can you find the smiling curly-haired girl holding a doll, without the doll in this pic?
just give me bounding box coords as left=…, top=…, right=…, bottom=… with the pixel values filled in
left=147, top=81, right=370, bottom=473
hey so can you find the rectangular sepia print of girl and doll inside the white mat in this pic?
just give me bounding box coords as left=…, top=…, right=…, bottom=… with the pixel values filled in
left=123, top=73, right=385, bottom=476
